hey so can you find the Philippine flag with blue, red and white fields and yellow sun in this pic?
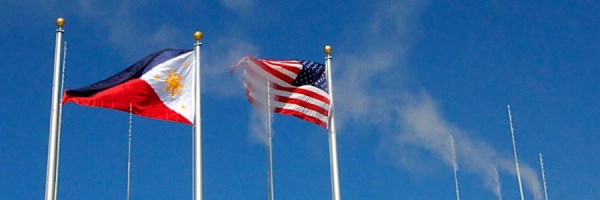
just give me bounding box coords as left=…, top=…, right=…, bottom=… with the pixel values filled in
left=62, top=49, right=196, bottom=124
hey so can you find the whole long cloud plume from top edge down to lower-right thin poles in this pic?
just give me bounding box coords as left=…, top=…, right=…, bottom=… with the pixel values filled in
left=334, top=0, right=542, bottom=199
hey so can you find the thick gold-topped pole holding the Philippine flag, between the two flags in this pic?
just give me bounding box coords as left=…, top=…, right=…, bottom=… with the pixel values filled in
left=193, top=31, right=202, bottom=200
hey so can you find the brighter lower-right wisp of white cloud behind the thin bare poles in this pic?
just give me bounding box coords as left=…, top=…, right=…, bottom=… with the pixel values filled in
left=395, top=96, right=542, bottom=199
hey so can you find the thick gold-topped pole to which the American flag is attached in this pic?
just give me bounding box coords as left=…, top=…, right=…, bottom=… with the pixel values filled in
left=324, top=45, right=341, bottom=200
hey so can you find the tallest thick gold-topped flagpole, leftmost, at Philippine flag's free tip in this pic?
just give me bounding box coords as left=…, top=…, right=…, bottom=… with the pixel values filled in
left=45, top=17, right=65, bottom=200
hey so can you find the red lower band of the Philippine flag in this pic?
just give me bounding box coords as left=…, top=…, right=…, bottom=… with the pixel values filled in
left=63, top=79, right=192, bottom=124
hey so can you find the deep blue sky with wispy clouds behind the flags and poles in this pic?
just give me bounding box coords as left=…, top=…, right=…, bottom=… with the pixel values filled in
left=0, top=0, right=600, bottom=199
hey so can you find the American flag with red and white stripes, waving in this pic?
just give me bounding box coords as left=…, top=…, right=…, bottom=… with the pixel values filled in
left=232, top=57, right=330, bottom=128
